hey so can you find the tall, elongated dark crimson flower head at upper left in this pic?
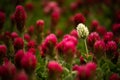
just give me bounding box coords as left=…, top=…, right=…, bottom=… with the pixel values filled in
left=14, top=5, right=27, bottom=32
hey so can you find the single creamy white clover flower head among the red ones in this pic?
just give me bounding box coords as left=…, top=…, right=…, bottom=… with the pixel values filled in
left=77, top=23, right=89, bottom=39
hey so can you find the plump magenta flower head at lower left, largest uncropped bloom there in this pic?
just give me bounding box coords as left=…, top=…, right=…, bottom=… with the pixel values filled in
left=21, top=52, right=37, bottom=74
